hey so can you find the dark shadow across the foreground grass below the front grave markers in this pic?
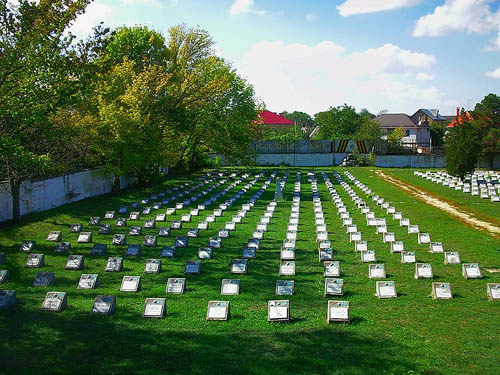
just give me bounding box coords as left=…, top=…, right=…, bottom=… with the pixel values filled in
left=0, top=307, right=422, bottom=374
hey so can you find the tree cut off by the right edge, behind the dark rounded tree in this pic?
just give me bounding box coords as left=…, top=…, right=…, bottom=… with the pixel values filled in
left=472, top=94, right=500, bottom=163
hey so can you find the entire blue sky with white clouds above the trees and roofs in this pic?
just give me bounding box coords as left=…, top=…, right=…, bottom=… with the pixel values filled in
left=69, top=0, right=500, bottom=115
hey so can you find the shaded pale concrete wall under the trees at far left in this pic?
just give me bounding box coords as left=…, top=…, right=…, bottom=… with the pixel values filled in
left=0, top=170, right=135, bottom=221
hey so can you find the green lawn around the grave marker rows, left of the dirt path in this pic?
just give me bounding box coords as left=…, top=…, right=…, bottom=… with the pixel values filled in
left=0, top=168, right=500, bottom=375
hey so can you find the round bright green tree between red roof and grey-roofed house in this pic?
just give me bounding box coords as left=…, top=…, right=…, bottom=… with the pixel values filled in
left=314, top=104, right=363, bottom=139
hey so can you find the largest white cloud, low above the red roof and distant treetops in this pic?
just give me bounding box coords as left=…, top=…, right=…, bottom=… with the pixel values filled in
left=236, top=41, right=453, bottom=114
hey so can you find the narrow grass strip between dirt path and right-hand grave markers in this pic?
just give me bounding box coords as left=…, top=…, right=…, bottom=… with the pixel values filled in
left=378, top=168, right=500, bottom=226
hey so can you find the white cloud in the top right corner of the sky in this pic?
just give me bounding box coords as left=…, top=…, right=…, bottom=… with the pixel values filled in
left=413, top=0, right=500, bottom=49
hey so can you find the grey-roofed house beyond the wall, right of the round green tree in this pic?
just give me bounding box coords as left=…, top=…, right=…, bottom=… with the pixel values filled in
left=375, top=110, right=431, bottom=147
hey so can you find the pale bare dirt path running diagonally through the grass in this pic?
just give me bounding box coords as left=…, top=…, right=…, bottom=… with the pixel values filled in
left=374, top=170, right=500, bottom=237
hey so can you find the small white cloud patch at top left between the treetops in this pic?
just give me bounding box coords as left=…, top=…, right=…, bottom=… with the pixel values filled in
left=70, top=0, right=118, bottom=38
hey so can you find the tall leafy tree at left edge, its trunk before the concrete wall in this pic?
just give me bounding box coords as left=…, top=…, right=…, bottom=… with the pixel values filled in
left=0, top=0, right=90, bottom=219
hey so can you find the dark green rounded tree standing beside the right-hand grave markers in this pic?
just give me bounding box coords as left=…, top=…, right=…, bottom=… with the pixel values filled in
left=445, top=113, right=481, bottom=180
